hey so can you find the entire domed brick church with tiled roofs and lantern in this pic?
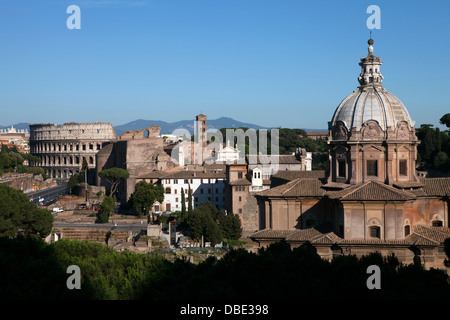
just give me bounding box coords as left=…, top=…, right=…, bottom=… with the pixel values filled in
left=250, top=39, right=450, bottom=268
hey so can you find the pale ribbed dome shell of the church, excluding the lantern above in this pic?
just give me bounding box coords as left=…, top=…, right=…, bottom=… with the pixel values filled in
left=331, top=86, right=414, bottom=130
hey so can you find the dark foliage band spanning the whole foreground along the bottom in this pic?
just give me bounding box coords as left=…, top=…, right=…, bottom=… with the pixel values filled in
left=0, top=237, right=450, bottom=301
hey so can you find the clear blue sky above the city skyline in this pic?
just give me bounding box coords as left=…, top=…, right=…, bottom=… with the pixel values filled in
left=0, top=0, right=450, bottom=129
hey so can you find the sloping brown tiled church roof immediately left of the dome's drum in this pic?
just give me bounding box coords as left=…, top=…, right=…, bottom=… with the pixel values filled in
left=256, top=179, right=325, bottom=197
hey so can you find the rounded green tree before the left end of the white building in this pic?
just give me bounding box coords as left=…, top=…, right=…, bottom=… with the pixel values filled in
left=130, top=181, right=164, bottom=216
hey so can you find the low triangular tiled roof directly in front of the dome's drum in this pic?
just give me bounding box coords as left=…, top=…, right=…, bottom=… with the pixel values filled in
left=327, top=180, right=415, bottom=201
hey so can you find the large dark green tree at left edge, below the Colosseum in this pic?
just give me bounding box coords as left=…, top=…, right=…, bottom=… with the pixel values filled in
left=0, top=184, right=53, bottom=238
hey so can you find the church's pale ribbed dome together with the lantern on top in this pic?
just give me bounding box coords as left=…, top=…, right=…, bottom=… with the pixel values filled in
left=329, top=40, right=414, bottom=131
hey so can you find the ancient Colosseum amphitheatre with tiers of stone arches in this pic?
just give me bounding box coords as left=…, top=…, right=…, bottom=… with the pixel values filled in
left=30, top=122, right=116, bottom=179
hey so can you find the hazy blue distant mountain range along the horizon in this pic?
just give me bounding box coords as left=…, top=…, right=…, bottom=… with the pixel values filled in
left=0, top=117, right=326, bottom=136
